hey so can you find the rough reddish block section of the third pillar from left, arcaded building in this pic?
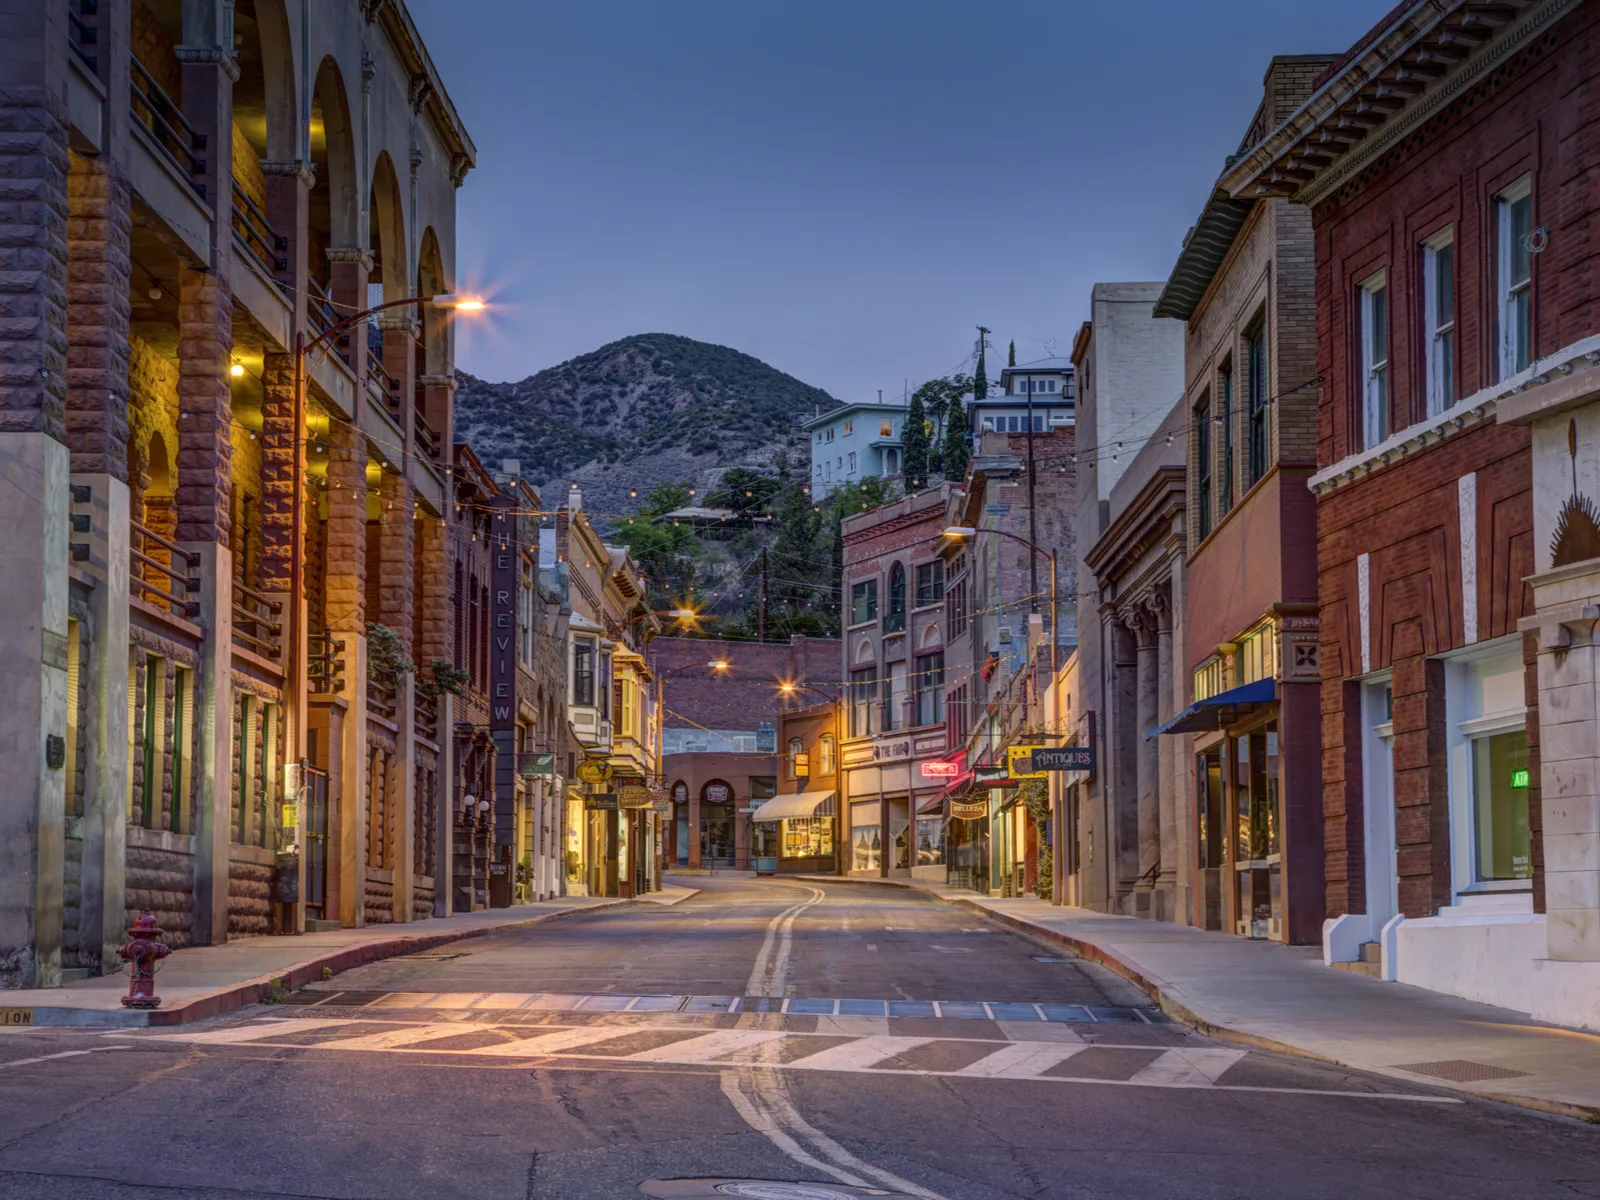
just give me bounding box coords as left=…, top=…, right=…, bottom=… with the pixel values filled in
left=178, top=267, right=234, bottom=546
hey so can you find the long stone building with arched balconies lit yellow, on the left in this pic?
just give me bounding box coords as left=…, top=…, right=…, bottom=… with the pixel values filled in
left=0, top=0, right=474, bottom=986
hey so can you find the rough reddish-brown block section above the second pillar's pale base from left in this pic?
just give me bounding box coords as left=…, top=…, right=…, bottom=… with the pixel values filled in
left=67, top=154, right=133, bottom=480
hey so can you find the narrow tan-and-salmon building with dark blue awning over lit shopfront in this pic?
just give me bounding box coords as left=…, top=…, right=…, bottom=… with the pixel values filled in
left=1150, top=54, right=1333, bottom=942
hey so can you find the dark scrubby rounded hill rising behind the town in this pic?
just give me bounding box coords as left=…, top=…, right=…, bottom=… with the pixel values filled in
left=456, top=333, right=838, bottom=515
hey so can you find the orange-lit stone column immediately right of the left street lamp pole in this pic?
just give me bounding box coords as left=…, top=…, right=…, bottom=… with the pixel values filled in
left=326, top=421, right=366, bottom=928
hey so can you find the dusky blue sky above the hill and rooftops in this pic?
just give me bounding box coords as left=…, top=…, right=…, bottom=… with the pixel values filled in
left=408, top=0, right=1392, bottom=400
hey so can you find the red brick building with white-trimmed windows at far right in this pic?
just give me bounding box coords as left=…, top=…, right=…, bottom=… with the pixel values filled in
left=1221, top=3, right=1600, bottom=1022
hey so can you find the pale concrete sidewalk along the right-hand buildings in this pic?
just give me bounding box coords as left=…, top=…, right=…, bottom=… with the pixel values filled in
left=794, top=875, right=1600, bottom=1123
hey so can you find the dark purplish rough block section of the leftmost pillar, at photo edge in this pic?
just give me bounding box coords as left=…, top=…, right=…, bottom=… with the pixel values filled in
left=0, top=86, right=69, bottom=442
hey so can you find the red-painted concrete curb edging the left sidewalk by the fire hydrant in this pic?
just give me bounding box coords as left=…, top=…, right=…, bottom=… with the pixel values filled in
left=23, top=896, right=636, bottom=1029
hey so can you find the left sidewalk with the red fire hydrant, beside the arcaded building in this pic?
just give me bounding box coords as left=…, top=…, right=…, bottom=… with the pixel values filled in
left=0, top=886, right=698, bottom=1029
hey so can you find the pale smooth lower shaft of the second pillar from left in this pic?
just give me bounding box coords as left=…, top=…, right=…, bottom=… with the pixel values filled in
left=72, top=475, right=130, bottom=974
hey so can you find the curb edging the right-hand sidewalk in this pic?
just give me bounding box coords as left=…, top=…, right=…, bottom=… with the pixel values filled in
left=790, top=875, right=1600, bottom=1125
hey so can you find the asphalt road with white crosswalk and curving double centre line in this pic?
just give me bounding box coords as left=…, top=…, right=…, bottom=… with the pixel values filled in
left=0, top=878, right=1600, bottom=1200
